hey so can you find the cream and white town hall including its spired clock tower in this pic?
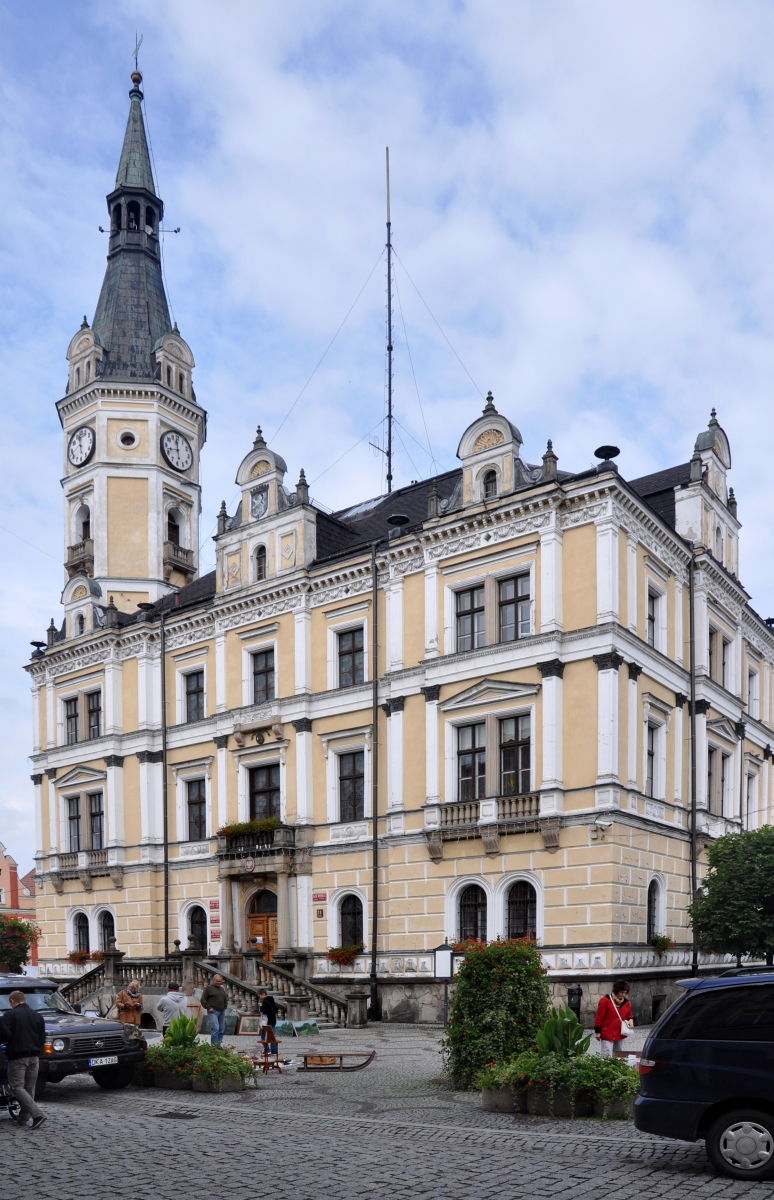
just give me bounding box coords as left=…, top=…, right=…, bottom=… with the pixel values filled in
left=22, top=74, right=774, bottom=1020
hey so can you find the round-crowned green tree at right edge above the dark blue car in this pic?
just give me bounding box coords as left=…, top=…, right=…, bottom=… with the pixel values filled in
left=689, top=826, right=774, bottom=962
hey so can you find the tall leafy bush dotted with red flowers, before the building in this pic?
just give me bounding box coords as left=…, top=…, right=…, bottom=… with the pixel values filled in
left=443, top=938, right=548, bottom=1088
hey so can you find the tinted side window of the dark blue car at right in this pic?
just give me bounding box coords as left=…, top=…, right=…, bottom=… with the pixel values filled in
left=659, top=984, right=774, bottom=1042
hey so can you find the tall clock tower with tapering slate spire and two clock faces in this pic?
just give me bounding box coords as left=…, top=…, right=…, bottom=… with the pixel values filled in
left=56, top=71, right=206, bottom=637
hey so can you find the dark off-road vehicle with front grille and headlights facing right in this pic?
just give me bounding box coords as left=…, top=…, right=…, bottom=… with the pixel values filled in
left=0, top=974, right=145, bottom=1099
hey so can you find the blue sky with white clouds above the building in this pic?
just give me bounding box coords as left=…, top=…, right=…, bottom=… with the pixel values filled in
left=0, top=0, right=774, bottom=871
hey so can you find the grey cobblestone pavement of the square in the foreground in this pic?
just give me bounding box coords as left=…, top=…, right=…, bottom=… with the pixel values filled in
left=0, top=1025, right=773, bottom=1200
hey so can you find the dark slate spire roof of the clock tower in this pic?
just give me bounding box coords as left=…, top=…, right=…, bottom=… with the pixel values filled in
left=92, top=79, right=172, bottom=380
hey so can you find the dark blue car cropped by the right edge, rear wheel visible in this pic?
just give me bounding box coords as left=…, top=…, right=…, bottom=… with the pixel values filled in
left=635, top=967, right=774, bottom=1180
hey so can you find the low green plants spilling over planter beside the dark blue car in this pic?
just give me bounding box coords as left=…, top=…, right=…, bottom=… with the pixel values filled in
left=475, top=1050, right=640, bottom=1117
